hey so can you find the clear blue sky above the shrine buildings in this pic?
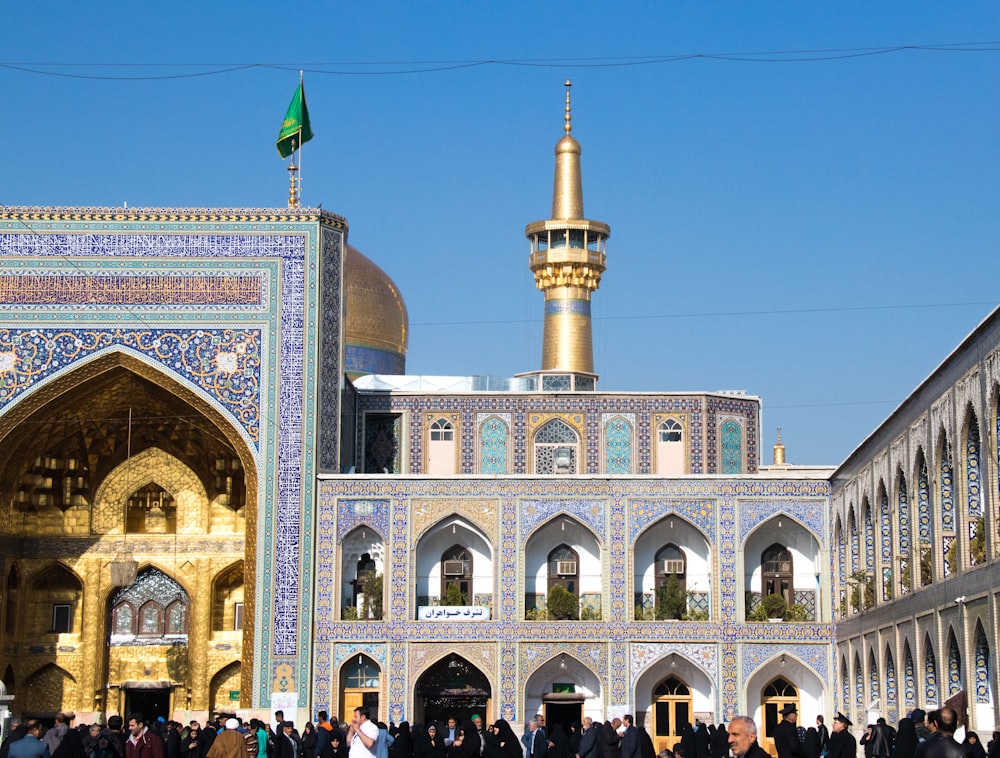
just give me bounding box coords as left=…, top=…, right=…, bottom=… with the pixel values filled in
left=0, top=0, right=1000, bottom=464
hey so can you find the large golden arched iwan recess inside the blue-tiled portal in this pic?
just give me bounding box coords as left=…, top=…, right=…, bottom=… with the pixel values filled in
left=0, top=362, right=255, bottom=721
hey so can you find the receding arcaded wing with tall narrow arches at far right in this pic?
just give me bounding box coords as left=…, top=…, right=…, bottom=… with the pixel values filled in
left=832, top=311, right=1000, bottom=733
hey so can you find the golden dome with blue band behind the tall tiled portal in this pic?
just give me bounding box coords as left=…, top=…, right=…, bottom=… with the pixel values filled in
left=344, top=245, right=410, bottom=377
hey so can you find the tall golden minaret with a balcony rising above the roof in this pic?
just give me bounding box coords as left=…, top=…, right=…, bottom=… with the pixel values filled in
left=524, top=79, right=611, bottom=375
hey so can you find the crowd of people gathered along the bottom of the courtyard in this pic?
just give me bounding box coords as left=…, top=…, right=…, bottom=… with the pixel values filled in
left=0, top=705, right=1000, bottom=758
